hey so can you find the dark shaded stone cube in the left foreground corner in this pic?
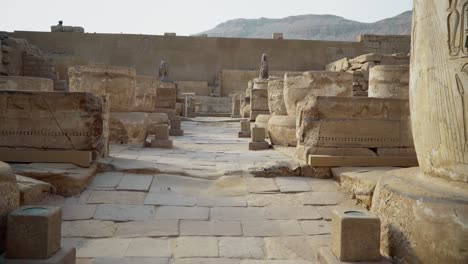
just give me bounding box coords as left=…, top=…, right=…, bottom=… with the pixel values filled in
left=6, top=206, right=62, bottom=259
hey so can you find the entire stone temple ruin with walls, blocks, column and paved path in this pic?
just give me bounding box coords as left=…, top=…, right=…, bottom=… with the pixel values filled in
left=0, top=0, right=468, bottom=264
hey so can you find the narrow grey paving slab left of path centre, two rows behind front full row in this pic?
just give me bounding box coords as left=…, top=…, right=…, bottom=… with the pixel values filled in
left=154, top=206, right=210, bottom=220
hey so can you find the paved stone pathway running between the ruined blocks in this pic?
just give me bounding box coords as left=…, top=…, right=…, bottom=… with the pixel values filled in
left=36, top=118, right=354, bottom=264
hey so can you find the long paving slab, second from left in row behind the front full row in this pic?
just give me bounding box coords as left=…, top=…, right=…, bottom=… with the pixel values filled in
left=115, top=220, right=179, bottom=237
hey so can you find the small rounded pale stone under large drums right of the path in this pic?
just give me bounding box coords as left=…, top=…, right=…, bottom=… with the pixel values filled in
left=268, top=115, right=297, bottom=147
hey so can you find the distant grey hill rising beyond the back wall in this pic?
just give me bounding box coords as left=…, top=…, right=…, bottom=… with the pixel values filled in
left=196, top=11, right=413, bottom=41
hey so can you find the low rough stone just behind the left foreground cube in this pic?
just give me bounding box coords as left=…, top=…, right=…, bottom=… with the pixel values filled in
left=16, top=175, right=52, bottom=205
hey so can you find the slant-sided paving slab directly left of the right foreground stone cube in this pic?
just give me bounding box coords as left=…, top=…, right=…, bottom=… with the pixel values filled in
left=265, top=237, right=315, bottom=262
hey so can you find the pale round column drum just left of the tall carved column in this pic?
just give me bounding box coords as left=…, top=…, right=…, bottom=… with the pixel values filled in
left=369, top=65, right=409, bottom=99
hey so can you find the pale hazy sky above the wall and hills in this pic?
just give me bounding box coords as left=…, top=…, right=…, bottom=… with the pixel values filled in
left=0, top=0, right=413, bottom=35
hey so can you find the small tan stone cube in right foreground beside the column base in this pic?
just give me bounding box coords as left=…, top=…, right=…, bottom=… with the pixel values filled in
left=331, top=210, right=381, bottom=262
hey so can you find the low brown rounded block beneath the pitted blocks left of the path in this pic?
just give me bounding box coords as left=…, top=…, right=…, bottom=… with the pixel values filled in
left=109, top=112, right=148, bottom=144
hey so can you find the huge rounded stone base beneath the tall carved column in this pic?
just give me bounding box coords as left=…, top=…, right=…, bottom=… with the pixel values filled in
left=371, top=169, right=468, bottom=264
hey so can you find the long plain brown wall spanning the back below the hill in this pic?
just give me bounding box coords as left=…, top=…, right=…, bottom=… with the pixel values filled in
left=10, top=31, right=409, bottom=84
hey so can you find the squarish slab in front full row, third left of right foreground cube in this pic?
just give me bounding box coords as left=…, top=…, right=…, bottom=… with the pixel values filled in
left=172, top=237, right=218, bottom=258
